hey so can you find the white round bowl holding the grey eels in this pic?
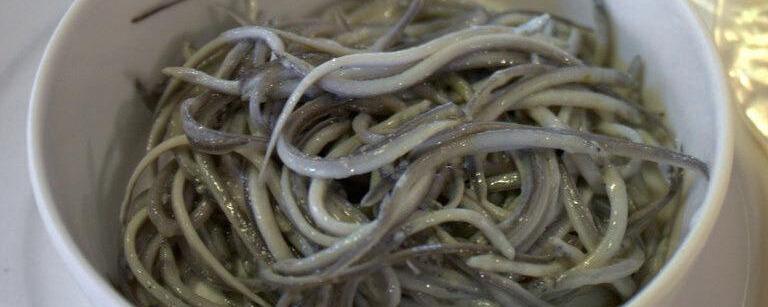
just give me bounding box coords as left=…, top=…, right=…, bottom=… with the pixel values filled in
left=28, top=0, right=733, bottom=306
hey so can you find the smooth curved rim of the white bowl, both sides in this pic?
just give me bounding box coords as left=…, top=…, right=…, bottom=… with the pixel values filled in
left=26, top=0, right=734, bottom=306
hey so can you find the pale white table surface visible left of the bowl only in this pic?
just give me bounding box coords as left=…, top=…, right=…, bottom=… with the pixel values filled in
left=0, top=0, right=88, bottom=306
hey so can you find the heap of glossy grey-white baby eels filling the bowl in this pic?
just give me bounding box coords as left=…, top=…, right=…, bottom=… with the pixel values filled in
left=120, top=0, right=708, bottom=306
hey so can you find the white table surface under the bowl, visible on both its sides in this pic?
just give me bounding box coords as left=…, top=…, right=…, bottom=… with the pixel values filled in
left=0, top=0, right=768, bottom=306
